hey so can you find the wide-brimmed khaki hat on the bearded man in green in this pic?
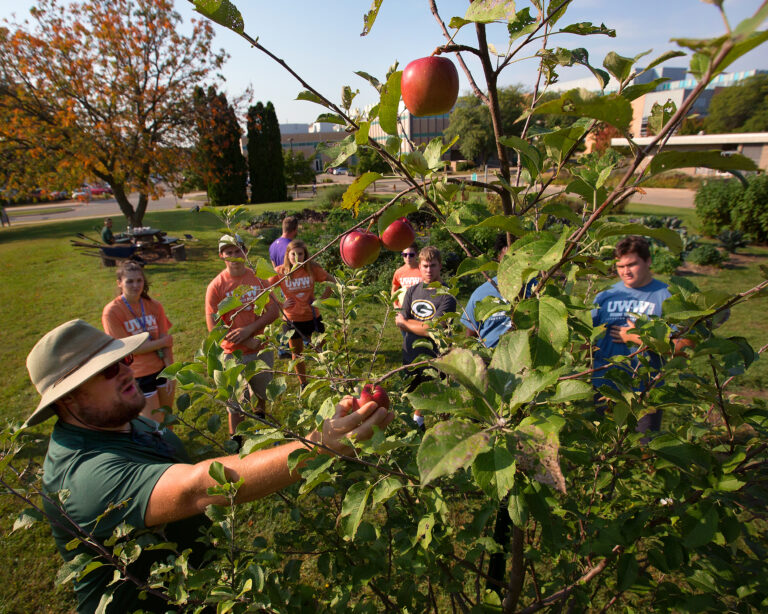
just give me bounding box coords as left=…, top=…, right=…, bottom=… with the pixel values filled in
left=24, top=320, right=149, bottom=427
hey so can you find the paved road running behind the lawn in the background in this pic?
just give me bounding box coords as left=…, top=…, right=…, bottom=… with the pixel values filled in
left=1, top=175, right=696, bottom=225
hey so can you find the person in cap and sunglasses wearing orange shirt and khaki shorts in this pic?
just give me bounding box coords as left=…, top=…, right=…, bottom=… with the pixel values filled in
left=205, top=235, right=280, bottom=435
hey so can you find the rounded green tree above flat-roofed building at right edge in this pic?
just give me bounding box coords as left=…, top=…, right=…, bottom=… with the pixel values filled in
left=704, top=75, right=768, bottom=134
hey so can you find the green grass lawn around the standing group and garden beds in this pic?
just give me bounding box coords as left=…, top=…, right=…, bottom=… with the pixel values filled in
left=0, top=201, right=768, bottom=613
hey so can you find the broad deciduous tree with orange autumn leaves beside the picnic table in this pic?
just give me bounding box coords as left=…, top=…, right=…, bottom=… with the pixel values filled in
left=0, top=0, right=227, bottom=226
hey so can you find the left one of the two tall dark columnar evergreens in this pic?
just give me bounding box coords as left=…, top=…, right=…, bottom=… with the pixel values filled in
left=194, top=87, right=248, bottom=206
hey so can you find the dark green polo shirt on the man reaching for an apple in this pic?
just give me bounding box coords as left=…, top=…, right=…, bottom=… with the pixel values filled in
left=43, top=418, right=208, bottom=613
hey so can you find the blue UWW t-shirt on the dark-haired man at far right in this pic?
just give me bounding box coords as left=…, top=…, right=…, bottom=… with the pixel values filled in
left=592, top=279, right=671, bottom=388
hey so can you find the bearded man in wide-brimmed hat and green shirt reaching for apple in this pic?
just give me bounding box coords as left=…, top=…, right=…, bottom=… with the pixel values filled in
left=25, top=320, right=392, bottom=612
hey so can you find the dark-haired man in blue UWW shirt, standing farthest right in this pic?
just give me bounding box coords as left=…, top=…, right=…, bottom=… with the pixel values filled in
left=592, top=236, right=671, bottom=432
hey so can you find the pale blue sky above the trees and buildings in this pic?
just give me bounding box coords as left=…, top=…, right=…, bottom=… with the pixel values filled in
left=0, top=0, right=768, bottom=123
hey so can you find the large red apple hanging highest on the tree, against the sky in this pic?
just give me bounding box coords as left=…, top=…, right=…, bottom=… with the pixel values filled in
left=400, top=55, right=459, bottom=117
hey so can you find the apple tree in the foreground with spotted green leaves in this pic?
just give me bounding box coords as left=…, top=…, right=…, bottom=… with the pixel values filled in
left=9, top=0, right=768, bottom=614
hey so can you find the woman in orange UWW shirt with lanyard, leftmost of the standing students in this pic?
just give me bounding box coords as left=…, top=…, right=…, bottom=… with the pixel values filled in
left=101, top=261, right=174, bottom=422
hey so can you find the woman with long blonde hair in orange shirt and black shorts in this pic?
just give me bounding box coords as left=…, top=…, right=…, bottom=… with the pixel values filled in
left=269, top=239, right=336, bottom=387
